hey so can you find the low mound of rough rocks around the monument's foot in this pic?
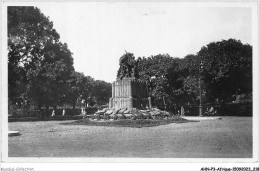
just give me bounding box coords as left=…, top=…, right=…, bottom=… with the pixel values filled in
left=83, top=108, right=170, bottom=120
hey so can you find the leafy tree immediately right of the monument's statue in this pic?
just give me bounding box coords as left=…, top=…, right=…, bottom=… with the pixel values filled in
left=138, top=54, right=183, bottom=109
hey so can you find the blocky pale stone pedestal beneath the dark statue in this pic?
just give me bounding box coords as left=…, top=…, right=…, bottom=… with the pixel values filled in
left=109, top=78, right=151, bottom=109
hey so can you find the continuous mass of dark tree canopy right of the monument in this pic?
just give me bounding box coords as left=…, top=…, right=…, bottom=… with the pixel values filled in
left=138, top=39, right=252, bottom=109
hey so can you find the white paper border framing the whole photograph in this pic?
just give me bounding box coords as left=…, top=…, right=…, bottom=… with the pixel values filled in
left=0, top=0, right=260, bottom=171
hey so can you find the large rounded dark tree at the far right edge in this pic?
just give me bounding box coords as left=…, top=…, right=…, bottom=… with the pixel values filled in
left=198, top=39, right=252, bottom=102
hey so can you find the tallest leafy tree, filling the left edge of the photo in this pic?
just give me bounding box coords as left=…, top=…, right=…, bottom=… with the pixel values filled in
left=8, top=7, right=74, bottom=108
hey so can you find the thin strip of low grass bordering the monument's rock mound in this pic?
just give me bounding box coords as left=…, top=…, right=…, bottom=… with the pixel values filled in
left=62, top=117, right=191, bottom=128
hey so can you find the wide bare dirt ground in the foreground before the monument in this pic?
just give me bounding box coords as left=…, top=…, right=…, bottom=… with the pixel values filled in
left=8, top=117, right=252, bottom=158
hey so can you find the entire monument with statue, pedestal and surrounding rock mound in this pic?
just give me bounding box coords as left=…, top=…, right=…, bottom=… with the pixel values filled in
left=84, top=52, right=169, bottom=120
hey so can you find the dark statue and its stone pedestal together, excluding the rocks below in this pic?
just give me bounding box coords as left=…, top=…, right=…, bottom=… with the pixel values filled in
left=109, top=52, right=152, bottom=109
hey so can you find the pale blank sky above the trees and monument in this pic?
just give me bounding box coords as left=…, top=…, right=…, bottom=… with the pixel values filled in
left=37, top=2, right=252, bottom=82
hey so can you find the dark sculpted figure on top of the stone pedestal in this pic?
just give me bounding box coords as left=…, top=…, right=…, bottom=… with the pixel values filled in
left=117, top=52, right=137, bottom=80
